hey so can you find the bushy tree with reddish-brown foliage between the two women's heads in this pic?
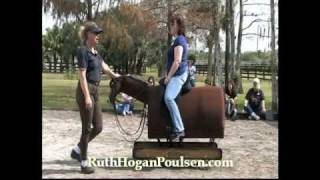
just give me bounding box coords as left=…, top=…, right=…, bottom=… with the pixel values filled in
left=97, top=3, right=156, bottom=74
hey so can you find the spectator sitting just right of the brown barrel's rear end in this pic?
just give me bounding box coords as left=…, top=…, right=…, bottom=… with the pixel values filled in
left=225, top=81, right=237, bottom=121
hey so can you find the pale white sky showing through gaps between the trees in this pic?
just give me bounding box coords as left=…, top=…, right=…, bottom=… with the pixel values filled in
left=42, top=0, right=278, bottom=52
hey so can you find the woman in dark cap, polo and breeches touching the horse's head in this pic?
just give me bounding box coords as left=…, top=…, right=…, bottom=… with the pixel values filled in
left=71, top=22, right=120, bottom=174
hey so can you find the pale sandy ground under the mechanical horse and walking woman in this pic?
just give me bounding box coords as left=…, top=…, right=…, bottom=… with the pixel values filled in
left=42, top=110, right=278, bottom=178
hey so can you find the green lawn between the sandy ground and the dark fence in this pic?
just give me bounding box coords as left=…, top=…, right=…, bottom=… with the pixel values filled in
left=42, top=72, right=271, bottom=111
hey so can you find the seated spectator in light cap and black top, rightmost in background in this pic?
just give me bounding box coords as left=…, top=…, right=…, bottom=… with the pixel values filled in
left=244, top=78, right=266, bottom=120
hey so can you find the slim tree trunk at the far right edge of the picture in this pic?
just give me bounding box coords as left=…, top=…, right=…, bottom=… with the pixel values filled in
left=270, top=0, right=278, bottom=112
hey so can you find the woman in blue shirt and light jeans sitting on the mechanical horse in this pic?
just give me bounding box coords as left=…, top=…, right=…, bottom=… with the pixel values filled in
left=164, top=14, right=188, bottom=141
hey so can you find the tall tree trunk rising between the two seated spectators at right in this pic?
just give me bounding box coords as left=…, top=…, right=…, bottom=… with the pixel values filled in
left=235, top=0, right=243, bottom=94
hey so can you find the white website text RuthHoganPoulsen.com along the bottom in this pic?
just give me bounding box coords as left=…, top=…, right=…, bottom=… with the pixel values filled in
left=87, top=156, right=233, bottom=170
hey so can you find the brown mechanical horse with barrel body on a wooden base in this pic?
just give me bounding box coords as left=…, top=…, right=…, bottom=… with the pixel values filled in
left=109, top=75, right=225, bottom=160
